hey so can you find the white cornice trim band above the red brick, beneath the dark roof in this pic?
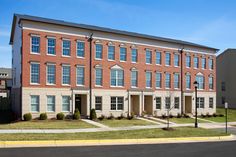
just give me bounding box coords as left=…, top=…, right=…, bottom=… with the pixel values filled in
left=22, top=26, right=216, bottom=56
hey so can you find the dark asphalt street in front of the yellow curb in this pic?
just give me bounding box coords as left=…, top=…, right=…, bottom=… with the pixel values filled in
left=0, top=141, right=236, bottom=157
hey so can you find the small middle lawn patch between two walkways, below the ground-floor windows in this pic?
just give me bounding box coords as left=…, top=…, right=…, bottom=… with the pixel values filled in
left=98, top=119, right=157, bottom=127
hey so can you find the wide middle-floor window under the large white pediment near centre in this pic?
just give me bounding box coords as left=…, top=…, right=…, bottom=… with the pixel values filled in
left=111, top=69, right=124, bottom=87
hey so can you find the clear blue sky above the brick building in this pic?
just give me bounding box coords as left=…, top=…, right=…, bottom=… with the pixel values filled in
left=0, top=0, right=236, bottom=67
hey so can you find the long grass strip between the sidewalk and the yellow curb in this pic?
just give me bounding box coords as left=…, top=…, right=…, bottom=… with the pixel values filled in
left=0, top=127, right=226, bottom=141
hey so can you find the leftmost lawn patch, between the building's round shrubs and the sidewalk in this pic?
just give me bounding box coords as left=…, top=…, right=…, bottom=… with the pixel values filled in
left=0, top=120, right=96, bottom=129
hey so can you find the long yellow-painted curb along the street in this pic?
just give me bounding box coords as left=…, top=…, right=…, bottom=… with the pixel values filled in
left=0, top=134, right=236, bottom=148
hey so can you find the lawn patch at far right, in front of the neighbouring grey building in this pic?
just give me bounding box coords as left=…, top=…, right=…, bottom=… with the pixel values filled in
left=200, top=108, right=236, bottom=122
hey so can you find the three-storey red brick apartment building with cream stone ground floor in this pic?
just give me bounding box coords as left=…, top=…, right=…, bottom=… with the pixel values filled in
left=10, top=14, right=218, bottom=117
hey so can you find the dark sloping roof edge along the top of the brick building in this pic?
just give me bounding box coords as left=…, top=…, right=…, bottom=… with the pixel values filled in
left=10, top=14, right=219, bottom=51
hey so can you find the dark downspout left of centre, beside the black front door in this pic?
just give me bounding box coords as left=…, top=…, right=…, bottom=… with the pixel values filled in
left=88, top=33, right=93, bottom=116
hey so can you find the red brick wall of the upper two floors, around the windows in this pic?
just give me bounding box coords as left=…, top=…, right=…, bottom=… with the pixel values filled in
left=22, top=30, right=216, bottom=91
